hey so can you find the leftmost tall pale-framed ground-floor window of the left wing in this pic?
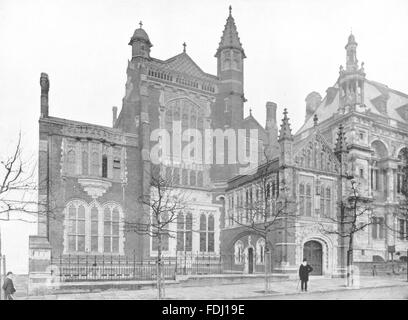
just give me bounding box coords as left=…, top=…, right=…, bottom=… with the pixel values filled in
left=68, top=205, right=85, bottom=252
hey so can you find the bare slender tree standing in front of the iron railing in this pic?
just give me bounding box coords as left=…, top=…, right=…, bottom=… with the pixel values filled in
left=125, top=166, right=188, bottom=299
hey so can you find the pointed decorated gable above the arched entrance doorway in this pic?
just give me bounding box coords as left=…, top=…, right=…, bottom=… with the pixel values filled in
left=294, top=131, right=340, bottom=174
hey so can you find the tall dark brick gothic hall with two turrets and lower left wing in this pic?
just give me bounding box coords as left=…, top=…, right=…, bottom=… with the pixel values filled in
left=38, top=8, right=268, bottom=259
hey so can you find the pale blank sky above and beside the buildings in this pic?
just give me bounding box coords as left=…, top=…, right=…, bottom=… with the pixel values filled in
left=0, top=0, right=408, bottom=270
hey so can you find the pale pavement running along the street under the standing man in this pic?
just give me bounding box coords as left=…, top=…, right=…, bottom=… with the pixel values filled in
left=20, top=276, right=408, bottom=300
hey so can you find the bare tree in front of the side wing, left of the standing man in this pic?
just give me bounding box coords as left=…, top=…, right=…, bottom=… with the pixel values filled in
left=229, top=161, right=296, bottom=292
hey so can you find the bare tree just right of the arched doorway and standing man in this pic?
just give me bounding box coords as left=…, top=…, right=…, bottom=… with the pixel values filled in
left=320, top=176, right=374, bottom=286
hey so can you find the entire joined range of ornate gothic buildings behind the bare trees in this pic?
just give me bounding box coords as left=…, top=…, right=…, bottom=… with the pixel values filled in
left=33, top=8, right=408, bottom=275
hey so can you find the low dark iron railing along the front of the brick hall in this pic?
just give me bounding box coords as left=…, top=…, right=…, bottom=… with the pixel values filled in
left=51, top=252, right=243, bottom=282
